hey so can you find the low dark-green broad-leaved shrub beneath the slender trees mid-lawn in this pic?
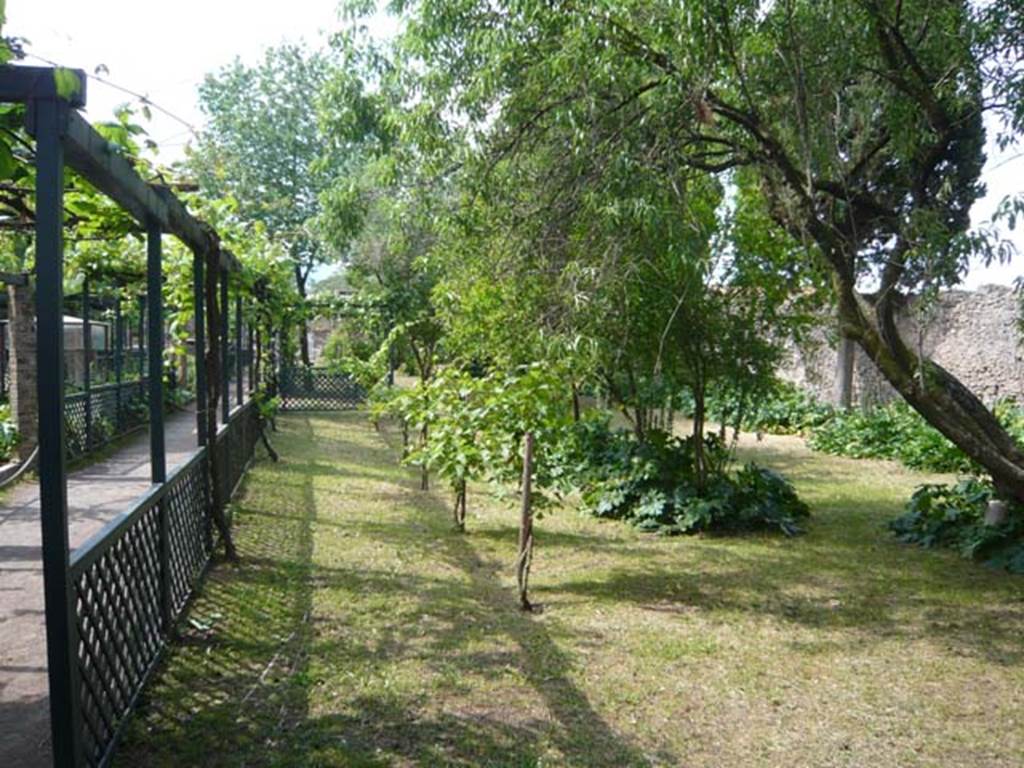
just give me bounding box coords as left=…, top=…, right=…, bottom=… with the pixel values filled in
left=577, top=422, right=809, bottom=536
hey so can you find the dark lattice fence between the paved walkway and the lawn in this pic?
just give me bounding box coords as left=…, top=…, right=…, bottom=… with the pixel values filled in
left=70, top=417, right=259, bottom=766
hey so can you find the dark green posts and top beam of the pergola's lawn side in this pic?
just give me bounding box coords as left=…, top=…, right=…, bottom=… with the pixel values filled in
left=0, top=66, right=242, bottom=767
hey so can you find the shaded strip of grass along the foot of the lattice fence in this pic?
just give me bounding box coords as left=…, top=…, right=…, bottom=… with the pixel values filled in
left=115, top=417, right=313, bottom=766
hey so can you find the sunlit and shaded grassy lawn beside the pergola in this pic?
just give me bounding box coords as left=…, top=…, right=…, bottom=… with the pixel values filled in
left=116, top=414, right=1024, bottom=768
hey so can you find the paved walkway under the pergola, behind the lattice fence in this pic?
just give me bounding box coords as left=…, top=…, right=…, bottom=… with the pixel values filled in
left=0, top=400, right=221, bottom=768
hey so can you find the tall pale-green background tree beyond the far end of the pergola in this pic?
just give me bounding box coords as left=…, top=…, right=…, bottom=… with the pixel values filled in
left=189, top=44, right=344, bottom=365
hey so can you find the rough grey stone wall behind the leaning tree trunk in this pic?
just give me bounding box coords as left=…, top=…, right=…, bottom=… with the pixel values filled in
left=780, top=286, right=1024, bottom=406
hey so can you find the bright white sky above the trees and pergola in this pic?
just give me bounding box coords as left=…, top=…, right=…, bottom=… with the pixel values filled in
left=4, top=0, right=1024, bottom=288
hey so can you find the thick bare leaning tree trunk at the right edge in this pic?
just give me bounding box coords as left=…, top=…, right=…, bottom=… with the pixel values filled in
left=839, top=284, right=1024, bottom=503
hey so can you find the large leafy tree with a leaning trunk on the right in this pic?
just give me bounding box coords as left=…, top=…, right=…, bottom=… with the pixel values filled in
left=380, top=0, right=1024, bottom=500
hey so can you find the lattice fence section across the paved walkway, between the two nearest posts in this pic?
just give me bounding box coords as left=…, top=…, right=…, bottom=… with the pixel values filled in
left=65, top=379, right=148, bottom=458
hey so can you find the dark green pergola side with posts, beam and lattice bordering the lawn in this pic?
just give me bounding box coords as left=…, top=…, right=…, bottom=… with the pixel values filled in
left=0, top=66, right=255, bottom=766
